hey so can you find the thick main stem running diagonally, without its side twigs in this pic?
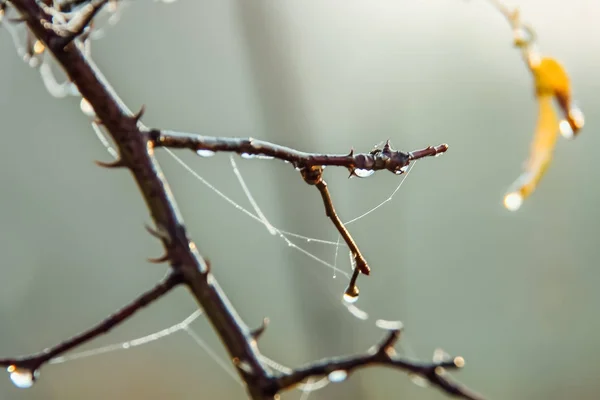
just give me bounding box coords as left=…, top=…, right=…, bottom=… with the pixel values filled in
left=11, top=0, right=272, bottom=399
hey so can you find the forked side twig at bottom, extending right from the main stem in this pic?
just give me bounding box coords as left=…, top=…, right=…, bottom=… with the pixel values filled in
left=276, top=329, right=482, bottom=400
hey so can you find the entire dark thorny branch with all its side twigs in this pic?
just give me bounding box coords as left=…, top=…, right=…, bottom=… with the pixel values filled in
left=0, top=0, right=478, bottom=399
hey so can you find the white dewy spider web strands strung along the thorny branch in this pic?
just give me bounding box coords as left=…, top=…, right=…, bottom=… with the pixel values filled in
left=3, top=5, right=432, bottom=400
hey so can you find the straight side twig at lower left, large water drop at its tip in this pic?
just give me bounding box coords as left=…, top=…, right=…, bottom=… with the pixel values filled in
left=0, top=272, right=183, bottom=384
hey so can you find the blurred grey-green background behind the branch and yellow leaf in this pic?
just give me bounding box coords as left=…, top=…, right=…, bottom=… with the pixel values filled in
left=0, top=0, right=600, bottom=400
